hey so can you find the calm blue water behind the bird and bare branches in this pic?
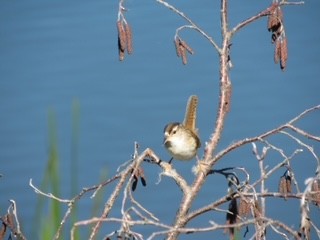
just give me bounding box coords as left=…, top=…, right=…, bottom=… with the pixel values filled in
left=0, top=0, right=320, bottom=239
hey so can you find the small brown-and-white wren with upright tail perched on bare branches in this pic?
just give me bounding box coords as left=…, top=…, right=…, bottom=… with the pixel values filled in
left=164, top=95, right=201, bottom=163
